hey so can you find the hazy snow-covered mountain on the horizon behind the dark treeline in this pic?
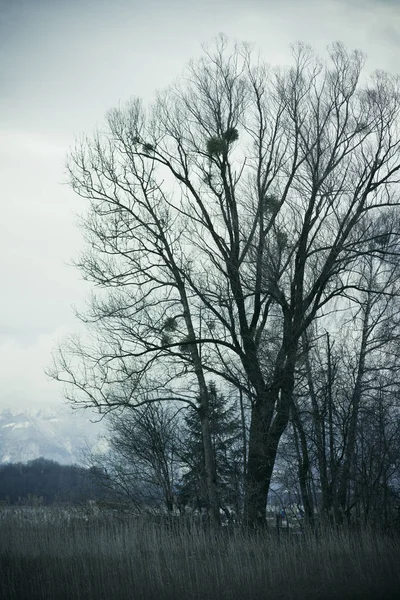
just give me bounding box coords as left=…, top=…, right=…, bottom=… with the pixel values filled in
left=0, top=405, right=103, bottom=464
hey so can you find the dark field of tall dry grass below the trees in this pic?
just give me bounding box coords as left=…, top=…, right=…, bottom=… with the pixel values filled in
left=0, top=513, right=400, bottom=600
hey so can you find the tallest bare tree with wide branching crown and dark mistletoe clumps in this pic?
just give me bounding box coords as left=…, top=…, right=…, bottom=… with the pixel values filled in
left=52, top=36, right=400, bottom=524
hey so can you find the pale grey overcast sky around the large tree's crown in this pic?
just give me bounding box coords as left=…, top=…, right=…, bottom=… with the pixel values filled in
left=0, top=0, right=400, bottom=408
